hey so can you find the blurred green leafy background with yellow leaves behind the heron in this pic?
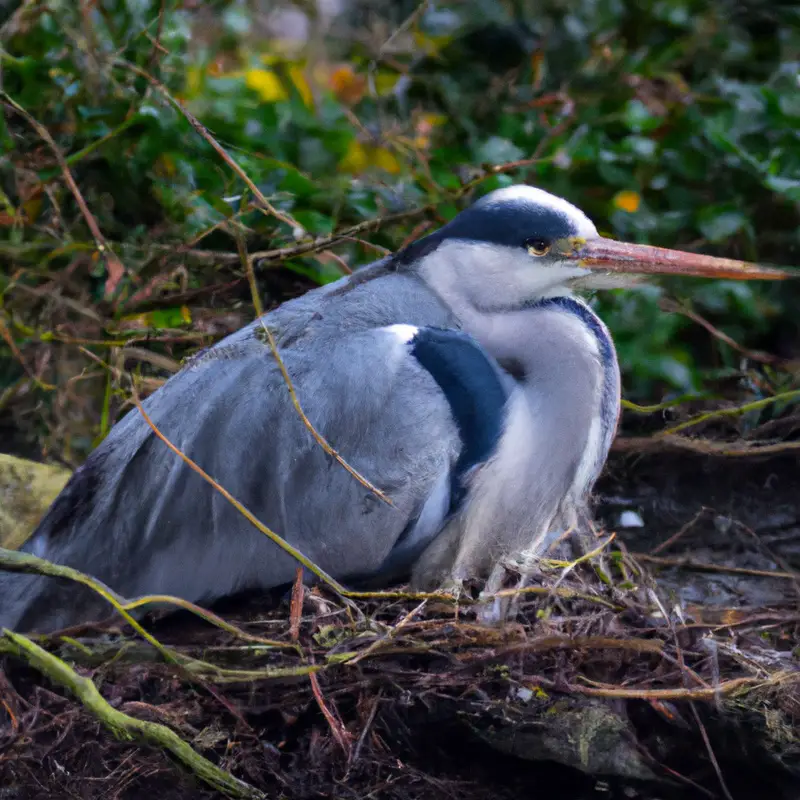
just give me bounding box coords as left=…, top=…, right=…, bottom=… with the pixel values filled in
left=0, top=0, right=800, bottom=464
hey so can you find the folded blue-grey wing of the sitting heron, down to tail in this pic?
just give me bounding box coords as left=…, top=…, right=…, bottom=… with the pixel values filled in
left=0, top=318, right=461, bottom=630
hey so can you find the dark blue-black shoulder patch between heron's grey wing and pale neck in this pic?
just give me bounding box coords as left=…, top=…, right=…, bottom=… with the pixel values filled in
left=411, top=328, right=508, bottom=506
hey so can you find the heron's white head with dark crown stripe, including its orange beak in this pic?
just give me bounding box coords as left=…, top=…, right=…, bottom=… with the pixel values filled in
left=396, top=185, right=790, bottom=311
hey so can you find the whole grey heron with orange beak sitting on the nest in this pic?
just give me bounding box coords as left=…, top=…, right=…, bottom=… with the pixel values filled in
left=0, top=186, right=786, bottom=631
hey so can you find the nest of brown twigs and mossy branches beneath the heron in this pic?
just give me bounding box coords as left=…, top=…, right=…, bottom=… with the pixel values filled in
left=0, top=551, right=800, bottom=798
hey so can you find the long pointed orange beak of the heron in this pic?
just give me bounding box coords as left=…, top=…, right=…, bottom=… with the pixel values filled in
left=565, top=237, right=800, bottom=281
